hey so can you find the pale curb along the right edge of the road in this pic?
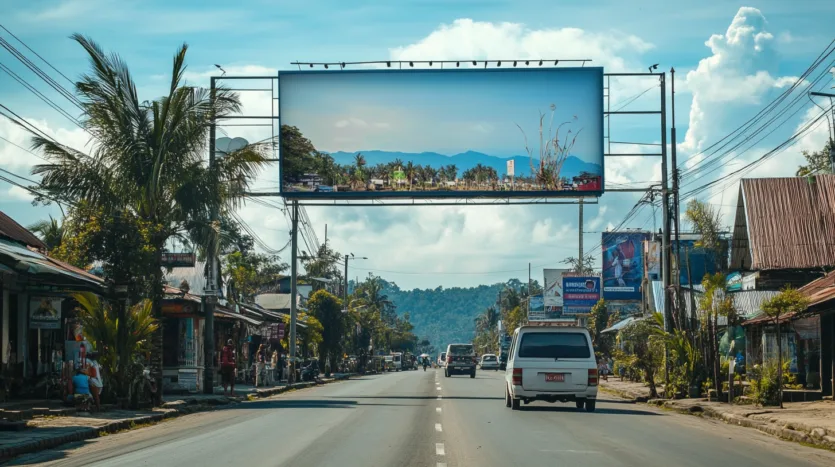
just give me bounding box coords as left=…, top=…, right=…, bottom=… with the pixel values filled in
left=650, top=399, right=835, bottom=450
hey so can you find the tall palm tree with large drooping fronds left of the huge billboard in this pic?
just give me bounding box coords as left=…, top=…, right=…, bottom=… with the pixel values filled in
left=32, top=34, right=269, bottom=402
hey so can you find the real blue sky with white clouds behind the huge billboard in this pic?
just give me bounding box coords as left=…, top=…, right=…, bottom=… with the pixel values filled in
left=0, top=0, right=835, bottom=288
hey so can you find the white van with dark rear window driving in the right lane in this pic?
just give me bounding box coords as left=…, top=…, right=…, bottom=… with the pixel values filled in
left=505, top=325, right=597, bottom=412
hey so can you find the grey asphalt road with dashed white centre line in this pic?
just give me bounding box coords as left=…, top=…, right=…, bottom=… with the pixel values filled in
left=12, top=370, right=835, bottom=467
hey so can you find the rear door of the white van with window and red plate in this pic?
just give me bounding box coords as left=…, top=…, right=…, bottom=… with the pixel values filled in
left=514, top=330, right=595, bottom=392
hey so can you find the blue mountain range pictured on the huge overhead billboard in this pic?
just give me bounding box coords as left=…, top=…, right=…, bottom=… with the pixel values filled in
left=330, top=150, right=603, bottom=178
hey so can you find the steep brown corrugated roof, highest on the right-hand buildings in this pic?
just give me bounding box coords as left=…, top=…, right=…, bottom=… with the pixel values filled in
left=731, top=175, right=835, bottom=270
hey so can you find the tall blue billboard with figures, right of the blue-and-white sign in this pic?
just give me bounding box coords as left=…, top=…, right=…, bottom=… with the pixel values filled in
left=602, top=232, right=649, bottom=300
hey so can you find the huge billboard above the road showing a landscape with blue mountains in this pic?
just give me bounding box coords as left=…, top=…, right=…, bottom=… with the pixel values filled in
left=279, top=67, right=604, bottom=199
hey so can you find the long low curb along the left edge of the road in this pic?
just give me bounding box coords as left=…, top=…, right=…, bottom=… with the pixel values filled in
left=0, top=373, right=355, bottom=462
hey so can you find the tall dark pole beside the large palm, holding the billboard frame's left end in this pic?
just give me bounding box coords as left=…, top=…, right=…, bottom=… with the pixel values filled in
left=203, top=76, right=218, bottom=394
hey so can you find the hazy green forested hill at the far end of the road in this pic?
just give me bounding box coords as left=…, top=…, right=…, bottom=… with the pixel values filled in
left=382, top=280, right=504, bottom=352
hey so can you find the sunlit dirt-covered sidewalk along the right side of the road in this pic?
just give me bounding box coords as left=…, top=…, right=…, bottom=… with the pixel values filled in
left=600, top=377, right=835, bottom=450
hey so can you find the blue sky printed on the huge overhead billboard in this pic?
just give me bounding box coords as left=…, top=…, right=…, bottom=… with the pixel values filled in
left=279, top=64, right=603, bottom=159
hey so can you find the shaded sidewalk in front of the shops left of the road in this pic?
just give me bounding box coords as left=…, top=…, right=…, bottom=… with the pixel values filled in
left=0, top=374, right=353, bottom=462
